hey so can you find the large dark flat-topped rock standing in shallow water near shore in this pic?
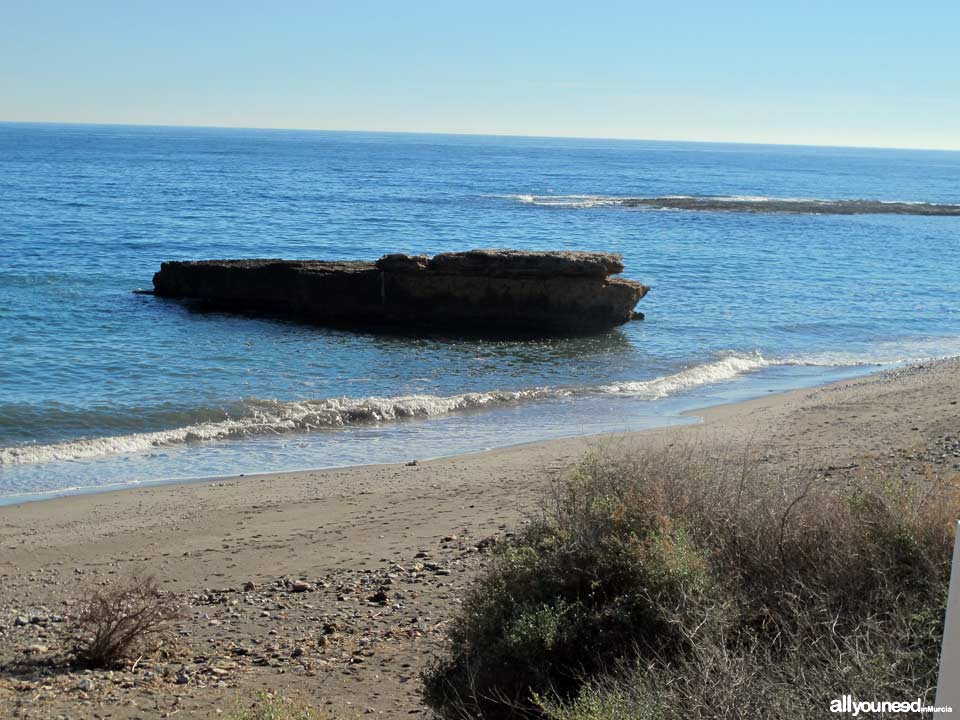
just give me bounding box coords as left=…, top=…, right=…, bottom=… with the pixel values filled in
left=153, top=250, right=649, bottom=336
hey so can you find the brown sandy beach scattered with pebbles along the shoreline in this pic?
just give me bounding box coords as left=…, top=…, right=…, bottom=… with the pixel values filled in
left=0, top=359, right=960, bottom=719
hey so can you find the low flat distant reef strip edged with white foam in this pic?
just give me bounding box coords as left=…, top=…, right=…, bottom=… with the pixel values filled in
left=500, top=195, right=960, bottom=216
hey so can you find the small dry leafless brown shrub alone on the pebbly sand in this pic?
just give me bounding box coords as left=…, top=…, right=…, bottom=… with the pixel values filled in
left=74, top=577, right=179, bottom=668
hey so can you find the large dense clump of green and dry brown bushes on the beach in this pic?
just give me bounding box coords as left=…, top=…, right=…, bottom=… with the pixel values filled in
left=424, top=447, right=960, bottom=720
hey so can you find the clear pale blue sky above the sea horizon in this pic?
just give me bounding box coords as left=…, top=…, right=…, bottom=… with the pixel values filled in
left=0, top=0, right=960, bottom=149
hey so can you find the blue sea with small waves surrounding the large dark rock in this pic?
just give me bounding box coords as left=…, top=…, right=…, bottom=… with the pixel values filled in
left=0, top=123, right=960, bottom=502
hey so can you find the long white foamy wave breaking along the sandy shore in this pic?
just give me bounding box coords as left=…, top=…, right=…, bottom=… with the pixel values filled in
left=0, top=354, right=872, bottom=466
